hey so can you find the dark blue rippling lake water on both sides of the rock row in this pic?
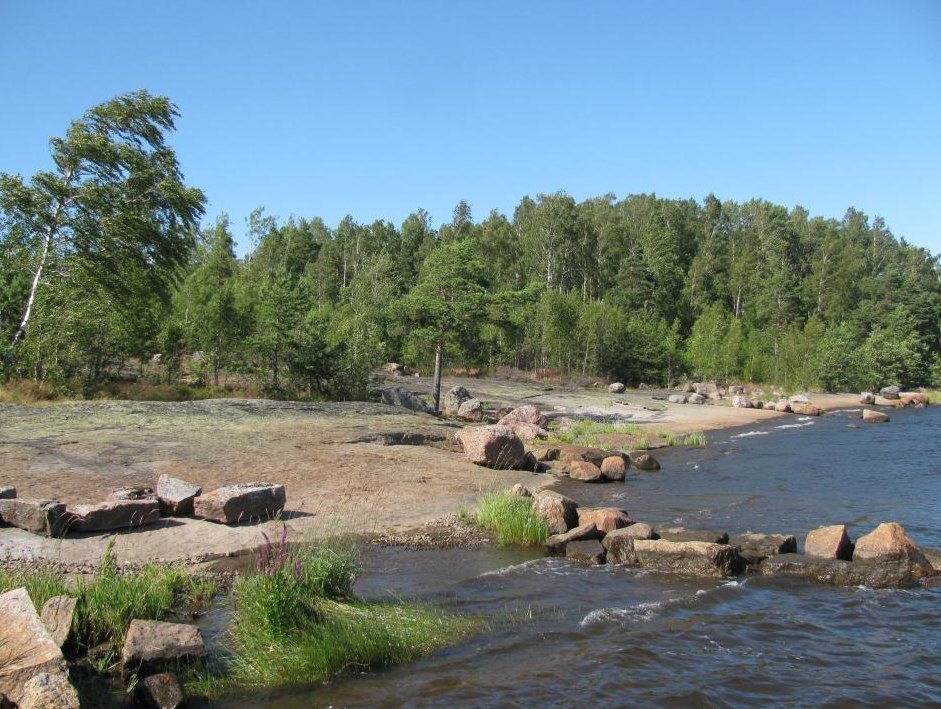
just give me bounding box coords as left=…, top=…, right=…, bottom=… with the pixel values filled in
left=222, top=407, right=941, bottom=709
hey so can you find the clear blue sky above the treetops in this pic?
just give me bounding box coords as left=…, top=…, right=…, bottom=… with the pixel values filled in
left=0, top=0, right=941, bottom=253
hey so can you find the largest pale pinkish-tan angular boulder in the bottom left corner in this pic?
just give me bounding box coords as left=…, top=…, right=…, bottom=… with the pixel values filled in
left=0, top=588, right=68, bottom=704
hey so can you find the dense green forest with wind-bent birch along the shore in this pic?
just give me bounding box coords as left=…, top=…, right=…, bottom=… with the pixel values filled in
left=0, top=92, right=941, bottom=398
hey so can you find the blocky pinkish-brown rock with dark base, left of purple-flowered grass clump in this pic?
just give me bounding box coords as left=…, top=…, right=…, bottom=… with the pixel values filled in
left=121, top=620, right=206, bottom=677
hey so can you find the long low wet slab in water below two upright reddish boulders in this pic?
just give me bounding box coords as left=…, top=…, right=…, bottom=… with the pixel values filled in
left=761, top=554, right=921, bottom=588
